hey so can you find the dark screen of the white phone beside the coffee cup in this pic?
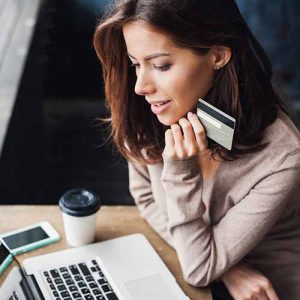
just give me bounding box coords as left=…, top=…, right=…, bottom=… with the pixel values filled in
left=2, top=226, right=49, bottom=250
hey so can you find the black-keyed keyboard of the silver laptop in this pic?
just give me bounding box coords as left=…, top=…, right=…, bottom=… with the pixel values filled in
left=43, top=259, right=118, bottom=300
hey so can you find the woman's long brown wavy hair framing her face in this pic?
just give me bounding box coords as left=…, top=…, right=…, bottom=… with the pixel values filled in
left=93, top=0, right=286, bottom=163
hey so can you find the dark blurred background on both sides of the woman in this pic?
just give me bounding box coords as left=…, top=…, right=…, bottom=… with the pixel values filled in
left=0, top=0, right=300, bottom=204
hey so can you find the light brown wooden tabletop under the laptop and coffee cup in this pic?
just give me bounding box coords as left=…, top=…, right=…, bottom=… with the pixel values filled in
left=0, top=205, right=211, bottom=300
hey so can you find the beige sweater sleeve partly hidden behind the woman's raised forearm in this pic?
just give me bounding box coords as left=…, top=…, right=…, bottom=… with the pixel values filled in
left=128, top=163, right=173, bottom=246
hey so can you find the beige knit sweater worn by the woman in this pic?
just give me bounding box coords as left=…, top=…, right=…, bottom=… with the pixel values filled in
left=129, top=112, right=300, bottom=300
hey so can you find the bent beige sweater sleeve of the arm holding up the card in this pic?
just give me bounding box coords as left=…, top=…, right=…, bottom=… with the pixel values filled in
left=162, top=151, right=300, bottom=286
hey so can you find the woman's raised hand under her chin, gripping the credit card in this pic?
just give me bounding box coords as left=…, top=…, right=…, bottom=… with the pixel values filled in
left=164, top=112, right=207, bottom=160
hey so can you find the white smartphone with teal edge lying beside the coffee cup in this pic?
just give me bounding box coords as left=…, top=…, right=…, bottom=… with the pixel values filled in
left=0, top=222, right=60, bottom=255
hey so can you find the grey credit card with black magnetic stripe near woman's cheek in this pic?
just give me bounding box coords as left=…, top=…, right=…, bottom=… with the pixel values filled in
left=197, top=99, right=235, bottom=150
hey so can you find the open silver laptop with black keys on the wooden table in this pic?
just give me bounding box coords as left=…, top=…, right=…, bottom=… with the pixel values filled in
left=0, top=234, right=189, bottom=300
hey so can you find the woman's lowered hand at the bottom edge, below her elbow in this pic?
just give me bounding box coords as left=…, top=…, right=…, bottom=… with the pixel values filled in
left=222, top=263, right=279, bottom=300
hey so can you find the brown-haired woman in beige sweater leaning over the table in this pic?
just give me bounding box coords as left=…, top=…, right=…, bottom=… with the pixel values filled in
left=94, top=0, right=300, bottom=300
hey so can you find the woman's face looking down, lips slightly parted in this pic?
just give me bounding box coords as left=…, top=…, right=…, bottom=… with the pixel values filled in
left=123, top=21, right=214, bottom=126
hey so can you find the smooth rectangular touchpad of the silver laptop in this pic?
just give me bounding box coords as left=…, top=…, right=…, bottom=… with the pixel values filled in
left=125, top=274, right=177, bottom=300
